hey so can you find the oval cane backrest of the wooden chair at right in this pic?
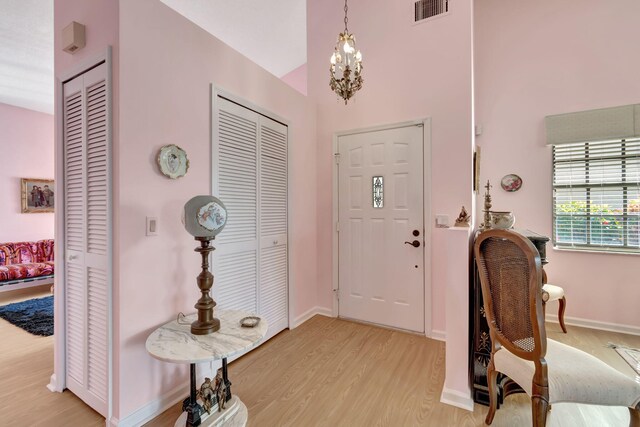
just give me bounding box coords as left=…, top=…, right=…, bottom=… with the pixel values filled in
left=474, top=230, right=547, bottom=361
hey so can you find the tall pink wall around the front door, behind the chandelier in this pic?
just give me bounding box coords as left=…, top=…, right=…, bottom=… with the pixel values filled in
left=307, top=0, right=473, bottom=331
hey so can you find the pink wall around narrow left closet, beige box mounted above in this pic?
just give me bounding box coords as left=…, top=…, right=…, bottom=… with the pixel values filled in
left=53, top=0, right=122, bottom=419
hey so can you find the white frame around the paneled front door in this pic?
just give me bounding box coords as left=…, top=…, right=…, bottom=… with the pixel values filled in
left=332, top=118, right=433, bottom=338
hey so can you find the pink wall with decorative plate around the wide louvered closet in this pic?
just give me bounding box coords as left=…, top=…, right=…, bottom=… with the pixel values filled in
left=117, top=0, right=317, bottom=419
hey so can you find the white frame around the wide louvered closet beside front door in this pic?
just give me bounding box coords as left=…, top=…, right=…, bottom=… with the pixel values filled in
left=210, top=83, right=295, bottom=329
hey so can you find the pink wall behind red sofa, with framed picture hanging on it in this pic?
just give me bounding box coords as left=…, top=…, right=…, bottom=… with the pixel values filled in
left=0, top=104, right=54, bottom=242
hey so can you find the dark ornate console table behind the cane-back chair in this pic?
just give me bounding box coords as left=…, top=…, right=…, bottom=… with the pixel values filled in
left=469, top=229, right=549, bottom=407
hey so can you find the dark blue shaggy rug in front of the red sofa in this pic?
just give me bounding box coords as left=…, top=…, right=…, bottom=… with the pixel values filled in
left=0, top=296, right=53, bottom=337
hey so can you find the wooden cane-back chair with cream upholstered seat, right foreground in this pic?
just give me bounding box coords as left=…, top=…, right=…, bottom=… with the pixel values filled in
left=474, top=230, right=640, bottom=427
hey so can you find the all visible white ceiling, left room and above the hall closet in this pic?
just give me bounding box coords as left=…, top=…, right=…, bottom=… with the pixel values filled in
left=0, top=0, right=307, bottom=114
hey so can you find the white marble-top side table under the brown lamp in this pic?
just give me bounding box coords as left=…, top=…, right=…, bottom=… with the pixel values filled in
left=146, top=309, right=268, bottom=427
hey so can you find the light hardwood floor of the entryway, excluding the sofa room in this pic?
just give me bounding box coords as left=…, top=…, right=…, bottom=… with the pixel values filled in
left=147, top=316, right=640, bottom=427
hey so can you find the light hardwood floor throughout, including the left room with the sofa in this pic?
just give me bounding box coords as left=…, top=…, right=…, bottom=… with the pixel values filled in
left=0, top=290, right=640, bottom=427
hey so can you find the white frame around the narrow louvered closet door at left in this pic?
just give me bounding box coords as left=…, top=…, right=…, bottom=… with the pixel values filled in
left=52, top=46, right=114, bottom=423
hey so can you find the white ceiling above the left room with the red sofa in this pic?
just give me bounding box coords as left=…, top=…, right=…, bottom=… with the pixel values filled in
left=0, top=0, right=53, bottom=114
